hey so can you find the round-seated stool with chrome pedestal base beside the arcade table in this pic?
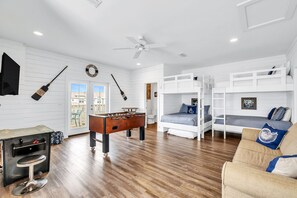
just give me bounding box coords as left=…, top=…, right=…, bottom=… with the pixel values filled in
left=12, top=155, right=47, bottom=196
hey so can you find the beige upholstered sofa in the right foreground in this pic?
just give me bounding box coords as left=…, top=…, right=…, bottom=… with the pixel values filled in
left=222, top=123, right=297, bottom=198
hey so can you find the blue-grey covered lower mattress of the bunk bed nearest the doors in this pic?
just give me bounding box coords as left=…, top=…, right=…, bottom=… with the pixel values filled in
left=161, top=113, right=212, bottom=126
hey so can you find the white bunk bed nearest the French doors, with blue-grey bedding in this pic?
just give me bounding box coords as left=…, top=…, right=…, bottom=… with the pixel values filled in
left=159, top=73, right=213, bottom=141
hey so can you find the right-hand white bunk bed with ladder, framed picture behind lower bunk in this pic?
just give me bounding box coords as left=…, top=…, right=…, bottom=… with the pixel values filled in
left=212, top=67, right=294, bottom=138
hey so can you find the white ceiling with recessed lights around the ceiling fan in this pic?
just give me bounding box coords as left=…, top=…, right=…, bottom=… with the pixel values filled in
left=0, top=0, right=297, bottom=69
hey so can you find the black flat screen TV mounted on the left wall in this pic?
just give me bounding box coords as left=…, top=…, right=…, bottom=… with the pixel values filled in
left=0, top=53, right=20, bottom=96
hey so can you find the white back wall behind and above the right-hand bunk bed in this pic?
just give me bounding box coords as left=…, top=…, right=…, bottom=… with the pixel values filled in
left=182, top=55, right=292, bottom=116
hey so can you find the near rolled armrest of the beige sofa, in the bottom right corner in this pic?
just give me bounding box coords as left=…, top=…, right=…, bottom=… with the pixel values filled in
left=222, top=162, right=297, bottom=198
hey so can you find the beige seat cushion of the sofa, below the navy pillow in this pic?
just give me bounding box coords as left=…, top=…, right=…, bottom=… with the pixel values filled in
left=233, top=140, right=282, bottom=170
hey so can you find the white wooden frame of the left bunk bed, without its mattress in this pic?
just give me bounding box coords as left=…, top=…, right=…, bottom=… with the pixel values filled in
left=160, top=73, right=213, bottom=141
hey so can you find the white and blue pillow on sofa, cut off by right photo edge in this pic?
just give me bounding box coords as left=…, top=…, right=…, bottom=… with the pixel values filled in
left=266, top=155, right=297, bottom=178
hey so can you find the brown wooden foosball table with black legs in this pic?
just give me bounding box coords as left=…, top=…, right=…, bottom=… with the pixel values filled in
left=89, top=112, right=145, bottom=157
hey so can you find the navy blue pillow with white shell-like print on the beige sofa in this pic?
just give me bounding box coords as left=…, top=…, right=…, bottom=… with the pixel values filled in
left=256, top=123, right=287, bottom=150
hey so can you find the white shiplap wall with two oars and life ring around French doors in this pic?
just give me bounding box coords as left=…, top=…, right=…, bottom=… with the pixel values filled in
left=0, top=40, right=132, bottom=136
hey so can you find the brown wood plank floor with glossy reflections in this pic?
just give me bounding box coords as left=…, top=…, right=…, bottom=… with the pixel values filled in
left=0, top=129, right=240, bottom=198
